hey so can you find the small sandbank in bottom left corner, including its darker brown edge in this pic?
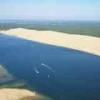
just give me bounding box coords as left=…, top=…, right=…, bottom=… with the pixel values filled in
left=0, top=88, right=51, bottom=100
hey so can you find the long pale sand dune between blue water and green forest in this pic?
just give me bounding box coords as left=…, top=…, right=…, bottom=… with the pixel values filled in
left=1, top=28, right=100, bottom=56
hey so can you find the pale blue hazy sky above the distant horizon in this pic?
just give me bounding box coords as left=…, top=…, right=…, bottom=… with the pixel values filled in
left=0, top=0, right=100, bottom=20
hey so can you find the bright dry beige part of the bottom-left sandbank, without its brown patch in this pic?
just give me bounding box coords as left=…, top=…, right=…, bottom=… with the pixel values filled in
left=0, top=89, right=35, bottom=100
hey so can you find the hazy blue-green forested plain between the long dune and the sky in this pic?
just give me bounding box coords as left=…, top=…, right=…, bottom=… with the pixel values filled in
left=0, top=20, right=100, bottom=37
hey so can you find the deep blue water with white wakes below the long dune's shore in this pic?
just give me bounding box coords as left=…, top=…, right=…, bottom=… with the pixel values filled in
left=0, top=35, right=100, bottom=100
